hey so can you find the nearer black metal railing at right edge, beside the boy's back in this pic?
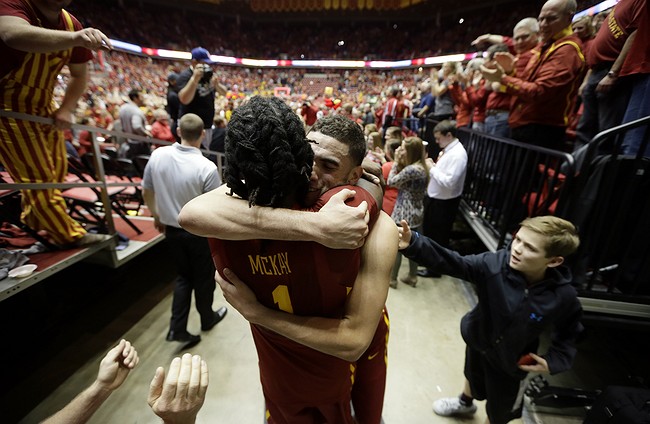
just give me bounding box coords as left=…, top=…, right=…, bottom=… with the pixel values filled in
left=564, top=116, right=650, bottom=318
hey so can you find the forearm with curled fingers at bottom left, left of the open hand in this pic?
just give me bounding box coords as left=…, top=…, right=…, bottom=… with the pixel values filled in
left=43, top=339, right=139, bottom=424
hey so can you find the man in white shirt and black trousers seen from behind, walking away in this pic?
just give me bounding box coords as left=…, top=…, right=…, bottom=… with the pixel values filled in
left=142, top=113, right=228, bottom=344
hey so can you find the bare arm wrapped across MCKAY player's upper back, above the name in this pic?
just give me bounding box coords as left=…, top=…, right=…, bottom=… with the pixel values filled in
left=178, top=185, right=369, bottom=249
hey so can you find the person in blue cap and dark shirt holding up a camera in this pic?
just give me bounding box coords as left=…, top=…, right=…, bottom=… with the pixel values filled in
left=176, top=47, right=226, bottom=149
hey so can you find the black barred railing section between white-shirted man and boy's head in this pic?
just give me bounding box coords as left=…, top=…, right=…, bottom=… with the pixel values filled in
left=458, top=128, right=575, bottom=251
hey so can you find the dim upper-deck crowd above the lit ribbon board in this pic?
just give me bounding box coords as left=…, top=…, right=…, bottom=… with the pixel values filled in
left=66, top=0, right=597, bottom=59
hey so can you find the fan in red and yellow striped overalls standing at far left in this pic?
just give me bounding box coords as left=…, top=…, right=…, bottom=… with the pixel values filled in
left=0, top=0, right=111, bottom=247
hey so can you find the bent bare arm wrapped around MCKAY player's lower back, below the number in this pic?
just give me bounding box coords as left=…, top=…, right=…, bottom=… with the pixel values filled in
left=216, top=212, right=398, bottom=361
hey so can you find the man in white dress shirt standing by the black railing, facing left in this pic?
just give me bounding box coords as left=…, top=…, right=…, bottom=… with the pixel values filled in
left=418, top=120, right=467, bottom=278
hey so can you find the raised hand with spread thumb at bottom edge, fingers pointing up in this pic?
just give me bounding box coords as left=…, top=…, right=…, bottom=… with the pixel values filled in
left=147, top=353, right=209, bottom=424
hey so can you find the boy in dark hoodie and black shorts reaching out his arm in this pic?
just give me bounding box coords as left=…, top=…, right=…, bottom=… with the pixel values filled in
left=400, top=216, right=582, bottom=424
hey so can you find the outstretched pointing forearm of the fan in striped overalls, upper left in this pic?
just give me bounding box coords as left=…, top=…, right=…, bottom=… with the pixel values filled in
left=0, top=16, right=112, bottom=53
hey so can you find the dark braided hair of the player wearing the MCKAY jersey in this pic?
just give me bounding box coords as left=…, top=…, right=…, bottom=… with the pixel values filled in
left=224, top=96, right=314, bottom=207
